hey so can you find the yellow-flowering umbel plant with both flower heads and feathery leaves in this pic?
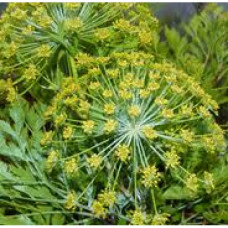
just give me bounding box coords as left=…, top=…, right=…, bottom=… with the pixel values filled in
left=0, top=3, right=228, bottom=225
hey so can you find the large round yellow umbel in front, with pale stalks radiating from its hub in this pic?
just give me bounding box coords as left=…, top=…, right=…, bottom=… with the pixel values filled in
left=41, top=52, right=225, bottom=224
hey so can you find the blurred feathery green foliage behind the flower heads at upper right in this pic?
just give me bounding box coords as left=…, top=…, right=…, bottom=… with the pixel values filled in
left=165, top=4, right=228, bottom=104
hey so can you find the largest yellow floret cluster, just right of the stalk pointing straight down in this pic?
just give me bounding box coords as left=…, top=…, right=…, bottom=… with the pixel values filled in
left=141, top=165, right=161, bottom=188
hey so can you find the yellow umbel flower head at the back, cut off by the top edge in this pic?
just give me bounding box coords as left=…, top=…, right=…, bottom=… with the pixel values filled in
left=0, top=3, right=158, bottom=94
